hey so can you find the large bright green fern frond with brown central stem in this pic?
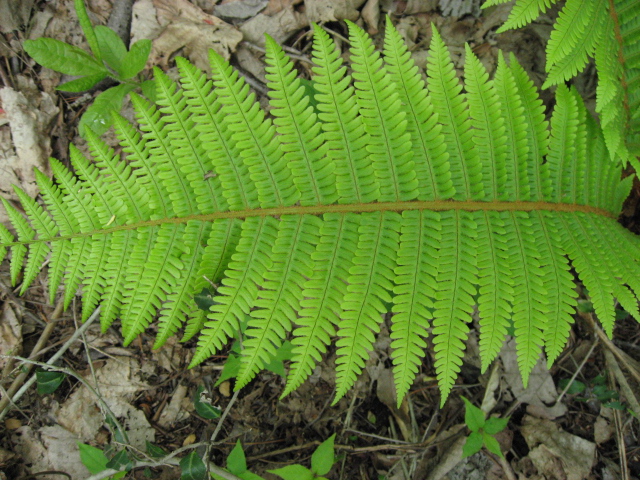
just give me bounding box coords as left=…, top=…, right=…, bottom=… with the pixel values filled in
left=0, top=21, right=640, bottom=402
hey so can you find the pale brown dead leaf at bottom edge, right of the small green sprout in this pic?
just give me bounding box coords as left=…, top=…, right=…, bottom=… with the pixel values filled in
left=520, top=415, right=596, bottom=480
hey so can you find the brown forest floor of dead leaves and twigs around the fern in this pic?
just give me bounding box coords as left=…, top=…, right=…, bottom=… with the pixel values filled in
left=0, top=0, right=640, bottom=480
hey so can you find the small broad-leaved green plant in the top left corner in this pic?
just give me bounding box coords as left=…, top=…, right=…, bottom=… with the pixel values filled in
left=24, top=0, right=155, bottom=135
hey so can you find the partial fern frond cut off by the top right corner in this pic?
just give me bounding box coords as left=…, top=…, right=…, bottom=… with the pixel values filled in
left=483, top=0, right=640, bottom=163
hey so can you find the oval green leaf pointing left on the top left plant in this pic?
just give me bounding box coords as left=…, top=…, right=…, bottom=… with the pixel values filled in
left=23, top=38, right=108, bottom=75
